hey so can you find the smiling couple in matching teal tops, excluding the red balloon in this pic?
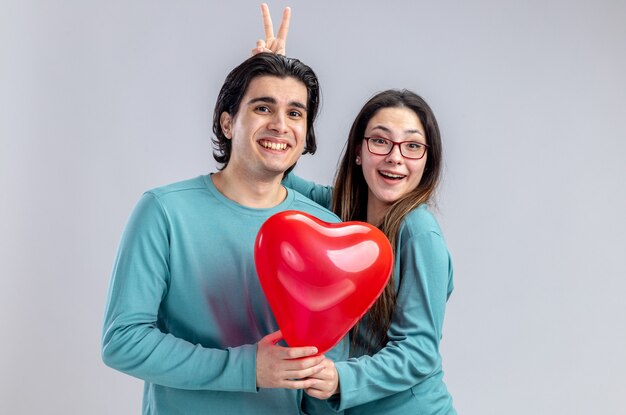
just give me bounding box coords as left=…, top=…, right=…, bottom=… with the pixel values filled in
left=102, top=5, right=455, bottom=415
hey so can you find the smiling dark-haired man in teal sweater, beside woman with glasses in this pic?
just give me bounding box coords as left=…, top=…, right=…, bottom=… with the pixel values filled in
left=102, top=53, right=346, bottom=415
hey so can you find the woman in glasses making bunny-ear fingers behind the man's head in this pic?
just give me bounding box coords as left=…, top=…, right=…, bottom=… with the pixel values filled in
left=253, top=6, right=456, bottom=415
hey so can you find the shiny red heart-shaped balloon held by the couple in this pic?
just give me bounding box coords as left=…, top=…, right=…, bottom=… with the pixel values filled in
left=254, top=210, right=393, bottom=353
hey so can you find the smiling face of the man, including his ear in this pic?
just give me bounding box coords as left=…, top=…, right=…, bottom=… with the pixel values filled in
left=220, top=75, right=307, bottom=180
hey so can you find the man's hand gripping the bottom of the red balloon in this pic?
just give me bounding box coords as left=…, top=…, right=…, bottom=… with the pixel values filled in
left=256, top=330, right=326, bottom=389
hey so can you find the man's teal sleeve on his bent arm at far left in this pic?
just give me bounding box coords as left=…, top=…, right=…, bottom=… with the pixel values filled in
left=102, top=194, right=256, bottom=392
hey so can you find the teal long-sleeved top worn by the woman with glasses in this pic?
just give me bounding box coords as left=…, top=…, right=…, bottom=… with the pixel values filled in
left=283, top=174, right=456, bottom=415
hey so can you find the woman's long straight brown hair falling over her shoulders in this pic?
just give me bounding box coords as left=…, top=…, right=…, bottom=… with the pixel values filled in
left=332, top=89, right=442, bottom=351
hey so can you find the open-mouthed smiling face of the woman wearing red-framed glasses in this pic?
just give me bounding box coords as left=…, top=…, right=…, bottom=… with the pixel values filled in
left=357, top=107, right=428, bottom=216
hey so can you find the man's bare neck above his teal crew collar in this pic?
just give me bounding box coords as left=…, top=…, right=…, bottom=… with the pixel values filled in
left=211, top=167, right=287, bottom=209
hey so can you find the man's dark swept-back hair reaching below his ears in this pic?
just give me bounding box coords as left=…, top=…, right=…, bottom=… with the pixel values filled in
left=213, top=53, right=320, bottom=172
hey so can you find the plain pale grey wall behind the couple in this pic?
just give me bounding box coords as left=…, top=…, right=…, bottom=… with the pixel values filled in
left=0, top=0, right=626, bottom=415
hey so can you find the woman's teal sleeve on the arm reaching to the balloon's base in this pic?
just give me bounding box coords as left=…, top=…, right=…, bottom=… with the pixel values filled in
left=336, top=219, right=452, bottom=413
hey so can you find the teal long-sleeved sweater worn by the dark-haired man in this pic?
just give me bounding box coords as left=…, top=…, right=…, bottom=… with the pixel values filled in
left=102, top=175, right=347, bottom=415
